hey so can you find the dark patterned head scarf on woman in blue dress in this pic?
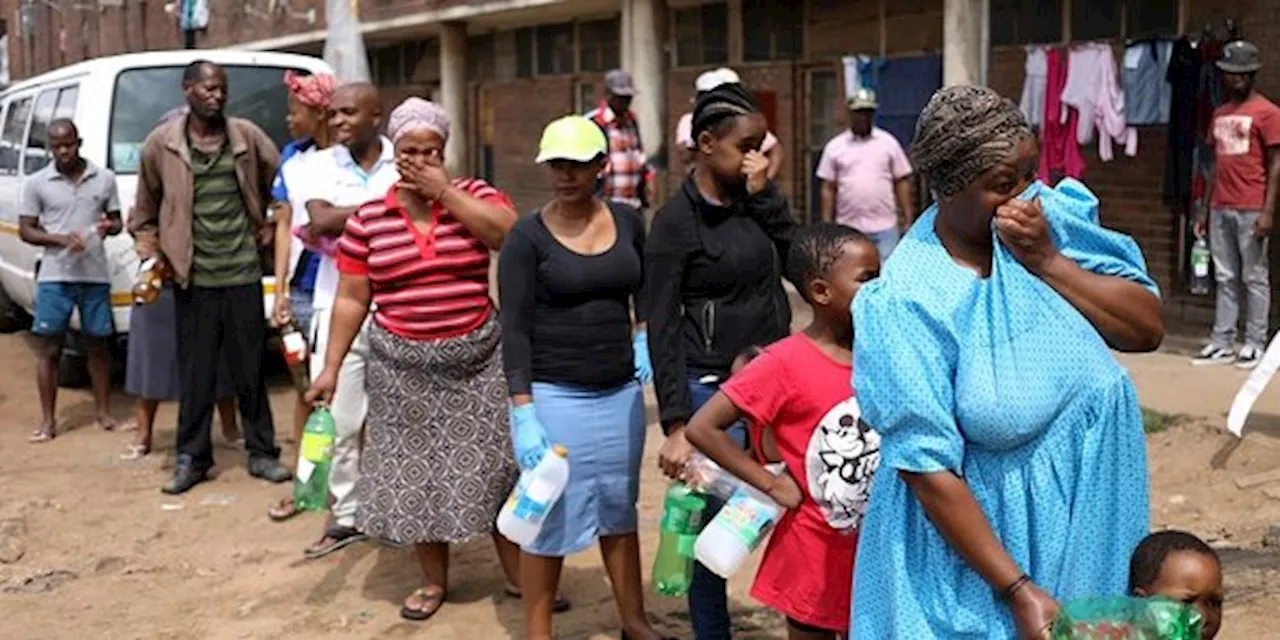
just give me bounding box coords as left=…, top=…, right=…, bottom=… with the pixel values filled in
left=911, top=84, right=1032, bottom=197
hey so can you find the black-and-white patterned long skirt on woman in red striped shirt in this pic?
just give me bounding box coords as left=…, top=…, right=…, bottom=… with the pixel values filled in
left=356, top=317, right=517, bottom=543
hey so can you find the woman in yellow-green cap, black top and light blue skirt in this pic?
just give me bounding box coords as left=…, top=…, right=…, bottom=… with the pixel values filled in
left=498, top=115, right=658, bottom=640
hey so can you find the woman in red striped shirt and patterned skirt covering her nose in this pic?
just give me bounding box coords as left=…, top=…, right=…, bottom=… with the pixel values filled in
left=307, top=97, right=520, bottom=620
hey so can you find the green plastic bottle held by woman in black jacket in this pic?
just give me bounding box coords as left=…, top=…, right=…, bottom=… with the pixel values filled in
left=653, top=483, right=707, bottom=596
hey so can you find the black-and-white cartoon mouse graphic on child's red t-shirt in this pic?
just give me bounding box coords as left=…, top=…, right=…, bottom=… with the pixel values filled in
left=805, top=398, right=879, bottom=531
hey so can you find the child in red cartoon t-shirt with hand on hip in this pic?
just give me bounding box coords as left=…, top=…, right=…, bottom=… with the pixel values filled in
left=687, top=223, right=879, bottom=640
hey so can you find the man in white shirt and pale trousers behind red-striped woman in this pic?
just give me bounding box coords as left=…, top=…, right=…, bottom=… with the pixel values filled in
left=291, top=83, right=399, bottom=558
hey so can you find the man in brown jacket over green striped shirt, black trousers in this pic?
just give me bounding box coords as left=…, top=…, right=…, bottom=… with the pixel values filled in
left=129, top=60, right=292, bottom=494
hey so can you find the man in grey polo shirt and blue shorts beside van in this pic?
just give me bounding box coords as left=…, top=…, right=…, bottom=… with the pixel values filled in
left=19, top=119, right=122, bottom=442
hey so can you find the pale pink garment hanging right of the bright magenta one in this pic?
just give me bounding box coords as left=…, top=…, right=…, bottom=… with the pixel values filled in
left=1059, top=44, right=1138, bottom=163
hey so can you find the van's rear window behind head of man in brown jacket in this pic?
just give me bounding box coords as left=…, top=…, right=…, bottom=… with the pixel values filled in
left=108, top=65, right=306, bottom=174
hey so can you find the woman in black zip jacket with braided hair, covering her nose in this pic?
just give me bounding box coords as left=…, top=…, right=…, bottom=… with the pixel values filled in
left=645, top=84, right=795, bottom=640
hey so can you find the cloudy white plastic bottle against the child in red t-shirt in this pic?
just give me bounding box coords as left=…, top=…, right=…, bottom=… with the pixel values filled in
left=694, top=465, right=783, bottom=580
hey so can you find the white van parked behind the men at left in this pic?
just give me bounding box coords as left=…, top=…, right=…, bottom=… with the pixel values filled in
left=0, top=50, right=332, bottom=378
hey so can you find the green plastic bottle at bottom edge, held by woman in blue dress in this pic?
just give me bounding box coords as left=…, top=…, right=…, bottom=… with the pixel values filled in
left=1052, top=596, right=1203, bottom=640
